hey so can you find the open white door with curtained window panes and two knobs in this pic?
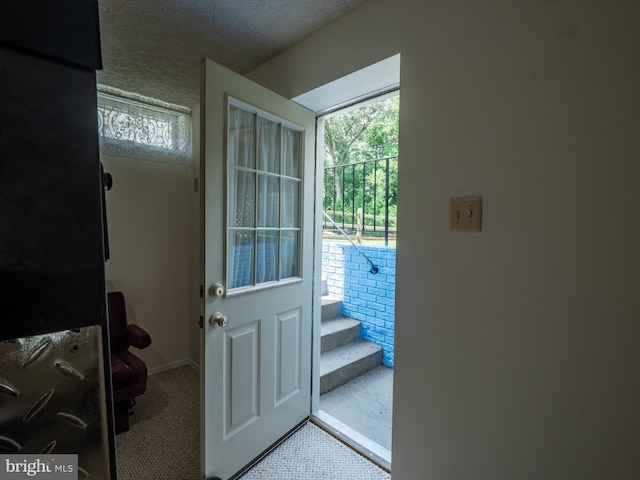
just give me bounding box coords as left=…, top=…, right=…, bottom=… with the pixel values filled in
left=200, top=60, right=315, bottom=480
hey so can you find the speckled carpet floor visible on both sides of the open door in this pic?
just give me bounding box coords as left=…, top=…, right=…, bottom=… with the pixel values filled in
left=116, top=366, right=390, bottom=480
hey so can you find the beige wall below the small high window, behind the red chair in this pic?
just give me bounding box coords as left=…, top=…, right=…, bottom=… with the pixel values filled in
left=101, top=156, right=197, bottom=369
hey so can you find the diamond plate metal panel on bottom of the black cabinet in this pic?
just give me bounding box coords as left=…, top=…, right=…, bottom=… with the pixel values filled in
left=0, top=325, right=110, bottom=479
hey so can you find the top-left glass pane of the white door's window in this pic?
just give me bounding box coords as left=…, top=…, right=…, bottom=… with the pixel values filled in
left=227, top=105, right=256, bottom=168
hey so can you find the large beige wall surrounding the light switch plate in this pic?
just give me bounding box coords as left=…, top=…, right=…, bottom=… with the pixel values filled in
left=249, top=0, right=640, bottom=480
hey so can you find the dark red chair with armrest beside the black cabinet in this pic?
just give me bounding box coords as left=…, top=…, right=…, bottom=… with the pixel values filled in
left=107, top=292, right=151, bottom=433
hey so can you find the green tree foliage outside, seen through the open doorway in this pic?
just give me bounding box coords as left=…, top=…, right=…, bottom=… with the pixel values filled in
left=324, top=95, right=400, bottom=230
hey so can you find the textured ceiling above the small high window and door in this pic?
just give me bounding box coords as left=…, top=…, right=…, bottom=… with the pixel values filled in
left=98, top=0, right=364, bottom=107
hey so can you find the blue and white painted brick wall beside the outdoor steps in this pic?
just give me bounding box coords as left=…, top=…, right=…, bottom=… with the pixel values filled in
left=322, top=242, right=396, bottom=367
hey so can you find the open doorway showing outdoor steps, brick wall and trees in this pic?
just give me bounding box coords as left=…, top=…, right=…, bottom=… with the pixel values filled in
left=293, top=55, right=400, bottom=470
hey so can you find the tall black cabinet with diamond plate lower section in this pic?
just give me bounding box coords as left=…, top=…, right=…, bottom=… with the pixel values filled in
left=0, top=0, right=116, bottom=478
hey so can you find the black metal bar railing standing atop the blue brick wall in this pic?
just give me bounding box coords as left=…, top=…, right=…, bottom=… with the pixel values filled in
left=323, top=156, right=398, bottom=246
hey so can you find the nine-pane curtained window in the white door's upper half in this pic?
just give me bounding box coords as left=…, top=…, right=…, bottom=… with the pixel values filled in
left=226, top=100, right=302, bottom=290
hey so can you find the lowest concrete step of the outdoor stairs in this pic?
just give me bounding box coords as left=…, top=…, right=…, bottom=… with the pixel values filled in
left=320, top=340, right=382, bottom=395
